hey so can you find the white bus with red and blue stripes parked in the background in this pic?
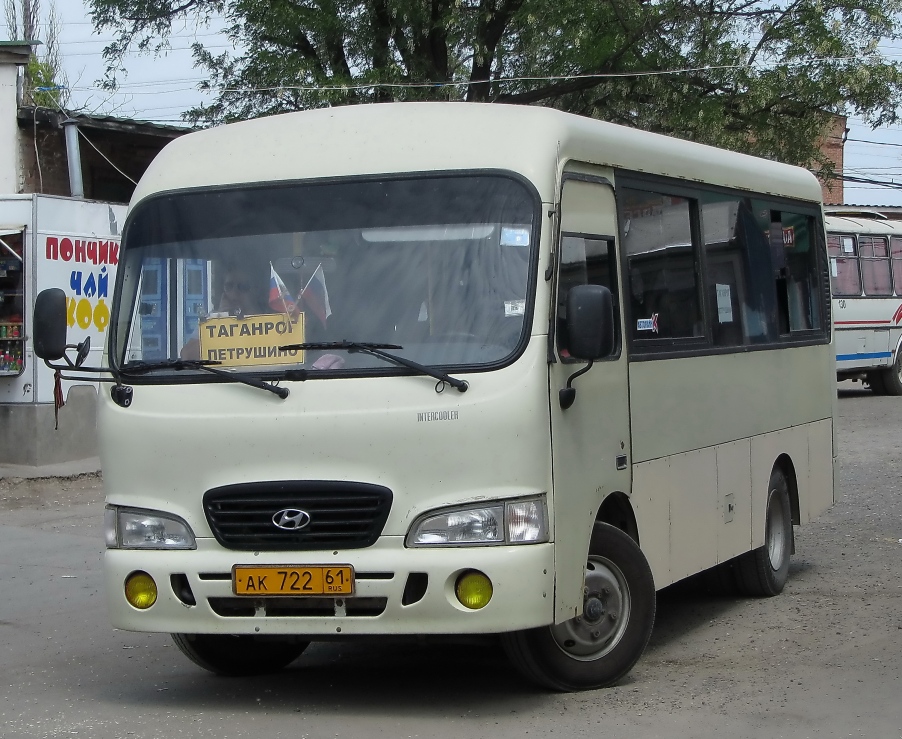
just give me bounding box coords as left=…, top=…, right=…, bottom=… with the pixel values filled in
left=825, top=213, right=902, bottom=395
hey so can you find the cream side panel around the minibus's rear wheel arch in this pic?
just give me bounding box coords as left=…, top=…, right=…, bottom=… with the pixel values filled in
left=752, top=424, right=811, bottom=549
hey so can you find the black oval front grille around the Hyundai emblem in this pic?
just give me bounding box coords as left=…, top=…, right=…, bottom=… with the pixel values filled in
left=204, top=480, right=392, bottom=551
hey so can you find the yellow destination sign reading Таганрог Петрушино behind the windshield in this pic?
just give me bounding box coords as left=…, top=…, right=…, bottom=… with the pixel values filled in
left=199, top=313, right=304, bottom=367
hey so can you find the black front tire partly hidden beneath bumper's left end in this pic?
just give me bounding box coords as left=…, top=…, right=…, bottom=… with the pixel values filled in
left=172, top=634, right=310, bottom=677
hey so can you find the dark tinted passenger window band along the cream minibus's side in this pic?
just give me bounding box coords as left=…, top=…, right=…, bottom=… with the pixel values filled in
left=618, top=178, right=828, bottom=355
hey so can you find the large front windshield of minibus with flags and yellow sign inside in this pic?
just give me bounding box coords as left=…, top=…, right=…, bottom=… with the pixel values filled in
left=110, top=174, right=537, bottom=381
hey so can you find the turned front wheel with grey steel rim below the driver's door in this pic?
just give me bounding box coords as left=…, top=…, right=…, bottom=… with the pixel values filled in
left=502, top=523, right=655, bottom=691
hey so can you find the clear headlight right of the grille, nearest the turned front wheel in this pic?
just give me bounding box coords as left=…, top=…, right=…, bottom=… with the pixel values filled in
left=407, top=497, right=548, bottom=547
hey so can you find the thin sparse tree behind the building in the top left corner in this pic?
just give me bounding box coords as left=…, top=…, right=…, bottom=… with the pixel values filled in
left=3, top=0, right=69, bottom=108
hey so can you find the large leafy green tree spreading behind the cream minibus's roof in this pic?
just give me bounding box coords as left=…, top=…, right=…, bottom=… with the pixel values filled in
left=88, top=0, right=902, bottom=175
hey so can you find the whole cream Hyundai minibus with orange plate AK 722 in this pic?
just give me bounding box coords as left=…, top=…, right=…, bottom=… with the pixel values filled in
left=35, top=103, right=836, bottom=690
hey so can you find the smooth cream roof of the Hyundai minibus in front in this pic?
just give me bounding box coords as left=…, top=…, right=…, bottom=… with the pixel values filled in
left=132, top=103, right=821, bottom=205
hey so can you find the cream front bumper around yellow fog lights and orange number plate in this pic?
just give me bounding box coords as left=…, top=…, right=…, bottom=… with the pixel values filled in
left=104, top=536, right=554, bottom=637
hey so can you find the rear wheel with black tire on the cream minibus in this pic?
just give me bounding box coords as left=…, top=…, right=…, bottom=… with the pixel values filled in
left=735, top=469, right=792, bottom=597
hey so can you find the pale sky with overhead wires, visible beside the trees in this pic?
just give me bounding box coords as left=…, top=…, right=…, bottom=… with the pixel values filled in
left=7, top=0, right=902, bottom=207
